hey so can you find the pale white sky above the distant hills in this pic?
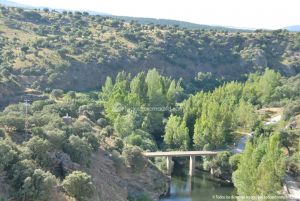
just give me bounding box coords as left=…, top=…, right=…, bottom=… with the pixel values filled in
left=10, top=0, right=300, bottom=29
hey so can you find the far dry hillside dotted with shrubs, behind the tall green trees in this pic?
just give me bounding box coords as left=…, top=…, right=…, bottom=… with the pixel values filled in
left=0, top=6, right=300, bottom=107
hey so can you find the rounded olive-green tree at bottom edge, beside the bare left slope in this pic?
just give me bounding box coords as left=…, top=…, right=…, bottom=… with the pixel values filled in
left=62, top=171, right=95, bottom=201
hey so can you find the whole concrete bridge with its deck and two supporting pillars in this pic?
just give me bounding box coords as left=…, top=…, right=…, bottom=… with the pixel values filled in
left=144, top=151, right=222, bottom=176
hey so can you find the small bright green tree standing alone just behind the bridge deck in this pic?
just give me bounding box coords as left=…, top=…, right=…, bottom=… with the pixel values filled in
left=164, top=115, right=190, bottom=150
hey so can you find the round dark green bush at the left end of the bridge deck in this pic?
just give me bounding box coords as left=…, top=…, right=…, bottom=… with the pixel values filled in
left=122, top=146, right=147, bottom=172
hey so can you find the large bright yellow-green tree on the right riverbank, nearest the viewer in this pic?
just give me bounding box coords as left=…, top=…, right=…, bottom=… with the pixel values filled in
left=233, top=134, right=284, bottom=196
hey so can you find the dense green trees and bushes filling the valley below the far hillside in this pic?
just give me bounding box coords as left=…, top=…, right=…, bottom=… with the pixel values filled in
left=0, top=66, right=300, bottom=200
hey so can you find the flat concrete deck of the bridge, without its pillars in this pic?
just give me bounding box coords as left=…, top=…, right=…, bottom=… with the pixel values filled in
left=144, top=151, right=221, bottom=157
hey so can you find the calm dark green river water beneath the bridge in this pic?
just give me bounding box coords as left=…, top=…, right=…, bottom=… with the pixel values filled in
left=161, top=163, right=235, bottom=201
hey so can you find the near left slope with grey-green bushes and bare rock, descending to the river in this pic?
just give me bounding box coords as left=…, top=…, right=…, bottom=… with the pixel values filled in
left=0, top=92, right=169, bottom=201
